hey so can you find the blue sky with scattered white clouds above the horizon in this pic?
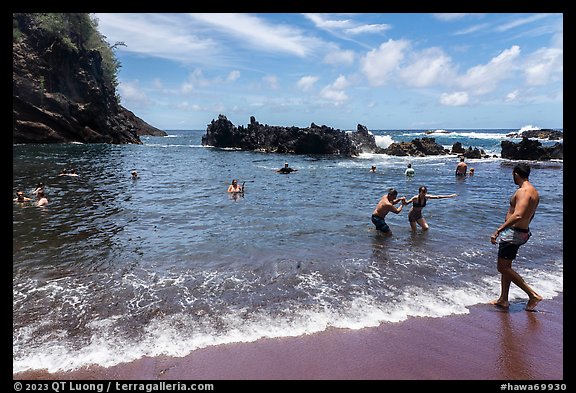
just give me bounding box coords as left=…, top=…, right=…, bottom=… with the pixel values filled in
left=94, top=13, right=563, bottom=130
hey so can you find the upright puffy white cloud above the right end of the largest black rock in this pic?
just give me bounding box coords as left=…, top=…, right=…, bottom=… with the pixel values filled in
left=361, top=39, right=409, bottom=86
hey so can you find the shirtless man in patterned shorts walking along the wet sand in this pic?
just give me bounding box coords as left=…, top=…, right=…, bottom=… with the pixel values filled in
left=490, top=163, right=543, bottom=311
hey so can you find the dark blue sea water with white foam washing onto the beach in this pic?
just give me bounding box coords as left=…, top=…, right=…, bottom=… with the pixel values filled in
left=13, top=129, right=564, bottom=372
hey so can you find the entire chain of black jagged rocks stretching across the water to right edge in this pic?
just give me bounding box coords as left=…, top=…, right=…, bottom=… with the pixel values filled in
left=202, top=114, right=563, bottom=160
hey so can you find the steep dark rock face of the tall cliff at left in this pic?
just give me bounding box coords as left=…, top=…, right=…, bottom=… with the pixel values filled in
left=12, top=14, right=167, bottom=144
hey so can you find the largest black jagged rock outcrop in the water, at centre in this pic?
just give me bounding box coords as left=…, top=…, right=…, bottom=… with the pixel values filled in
left=202, top=115, right=380, bottom=156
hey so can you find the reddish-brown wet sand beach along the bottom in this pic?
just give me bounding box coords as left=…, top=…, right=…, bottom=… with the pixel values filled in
left=13, top=294, right=564, bottom=381
